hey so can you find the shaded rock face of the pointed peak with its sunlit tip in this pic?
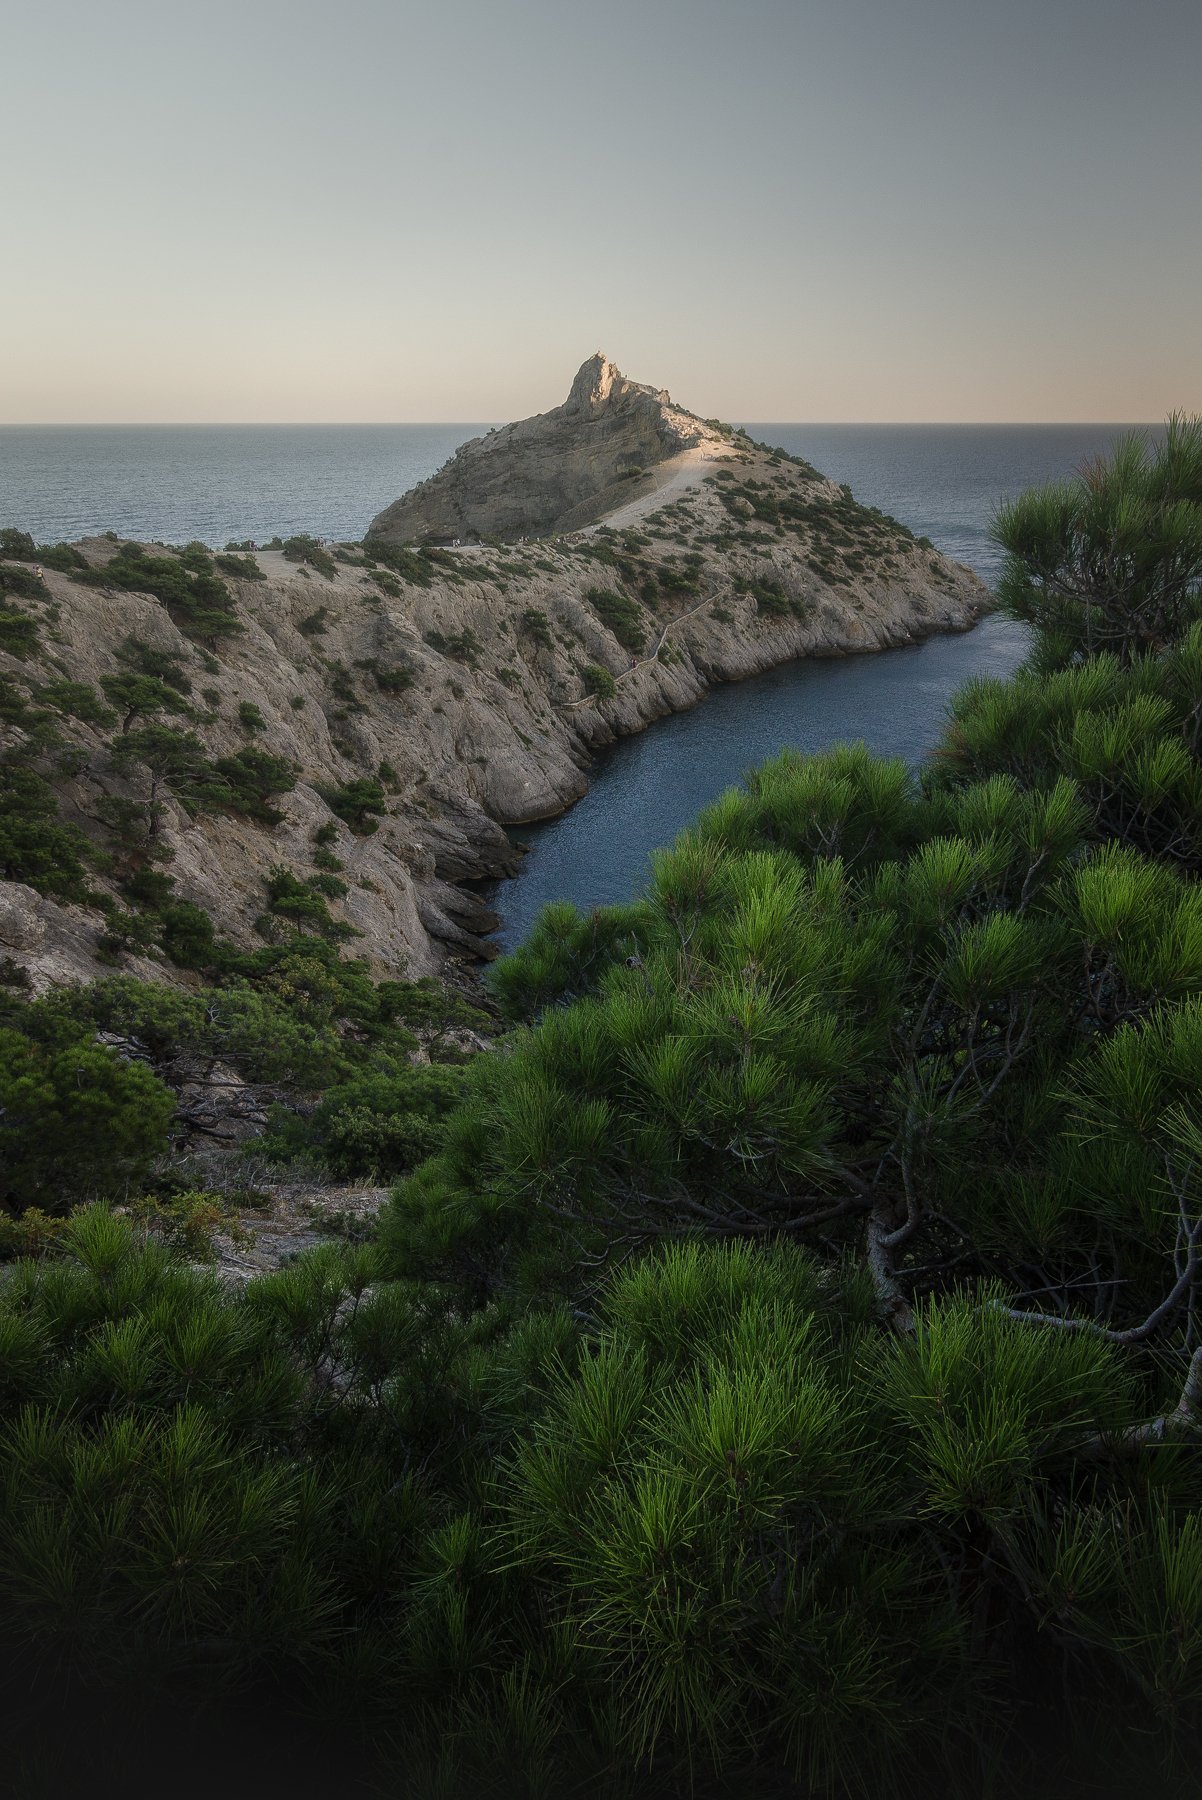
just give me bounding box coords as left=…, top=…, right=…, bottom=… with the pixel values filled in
left=369, top=351, right=723, bottom=544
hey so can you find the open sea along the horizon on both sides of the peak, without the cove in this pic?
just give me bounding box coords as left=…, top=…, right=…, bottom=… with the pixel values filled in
left=0, top=423, right=1159, bottom=581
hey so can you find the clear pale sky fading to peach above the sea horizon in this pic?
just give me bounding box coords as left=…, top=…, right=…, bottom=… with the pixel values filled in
left=9, top=0, right=1202, bottom=423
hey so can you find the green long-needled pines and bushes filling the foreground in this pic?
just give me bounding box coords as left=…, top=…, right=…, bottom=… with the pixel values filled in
left=0, top=421, right=1202, bottom=1800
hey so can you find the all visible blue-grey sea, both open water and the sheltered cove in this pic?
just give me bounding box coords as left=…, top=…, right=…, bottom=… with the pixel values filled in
left=0, top=421, right=1161, bottom=947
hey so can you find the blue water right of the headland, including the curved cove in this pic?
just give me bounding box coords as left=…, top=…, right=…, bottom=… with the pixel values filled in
left=486, top=425, right=1157, bottom=947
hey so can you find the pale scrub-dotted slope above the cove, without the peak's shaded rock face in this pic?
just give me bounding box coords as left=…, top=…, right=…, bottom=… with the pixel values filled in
left=0, top=365, right=988, bottom=986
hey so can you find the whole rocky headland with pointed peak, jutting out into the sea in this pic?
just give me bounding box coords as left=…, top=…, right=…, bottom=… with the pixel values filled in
left=0, top=356, right=988, bottom=990
